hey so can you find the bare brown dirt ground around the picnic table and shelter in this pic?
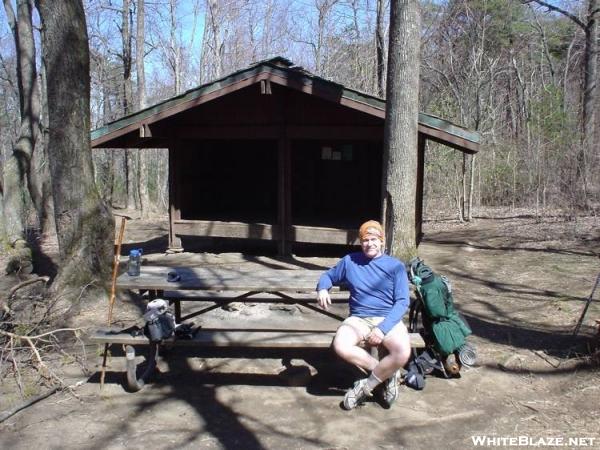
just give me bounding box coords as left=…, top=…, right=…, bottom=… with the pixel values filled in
left=0, top=211, right=600, bottom=449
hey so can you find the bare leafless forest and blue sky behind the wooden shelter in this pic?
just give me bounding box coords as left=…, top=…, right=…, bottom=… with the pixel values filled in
left=0, top=0, right=600, bottom=236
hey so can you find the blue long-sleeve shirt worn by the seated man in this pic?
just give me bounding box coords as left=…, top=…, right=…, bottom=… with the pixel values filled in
left=317, top=252, right=409, bottom=334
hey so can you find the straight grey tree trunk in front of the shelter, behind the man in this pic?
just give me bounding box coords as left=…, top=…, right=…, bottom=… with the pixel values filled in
left=383, top=0, right=421, bottom=261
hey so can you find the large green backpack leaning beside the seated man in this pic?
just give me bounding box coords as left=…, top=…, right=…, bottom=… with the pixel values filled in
left=409, top=258, right=472, bottom=356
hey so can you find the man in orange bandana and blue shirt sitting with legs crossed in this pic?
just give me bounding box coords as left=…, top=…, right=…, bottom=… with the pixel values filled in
left=317, top=220, right=411, bottom=409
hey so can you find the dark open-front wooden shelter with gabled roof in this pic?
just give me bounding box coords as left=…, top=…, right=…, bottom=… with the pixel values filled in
left=92, top=57, right=479, bottom=253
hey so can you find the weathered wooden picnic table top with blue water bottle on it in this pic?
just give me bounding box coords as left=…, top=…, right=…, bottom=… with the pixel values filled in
left=116, top=265, right=324, bottom=292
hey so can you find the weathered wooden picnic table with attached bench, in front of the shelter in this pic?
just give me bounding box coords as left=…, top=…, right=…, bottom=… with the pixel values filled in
left=90, top=266, right=425, bottom=391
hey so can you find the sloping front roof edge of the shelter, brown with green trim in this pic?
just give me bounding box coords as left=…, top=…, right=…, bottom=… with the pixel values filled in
left=91, top=57, right=480, bottom=151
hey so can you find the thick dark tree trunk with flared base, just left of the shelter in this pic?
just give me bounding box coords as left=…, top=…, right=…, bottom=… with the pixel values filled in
left=37, top=0, right=114, bottom=298
